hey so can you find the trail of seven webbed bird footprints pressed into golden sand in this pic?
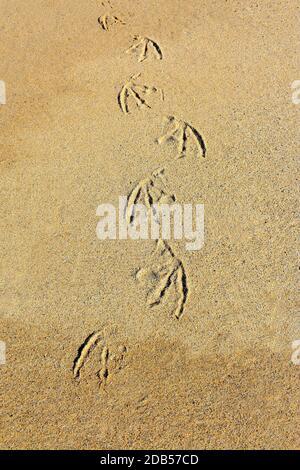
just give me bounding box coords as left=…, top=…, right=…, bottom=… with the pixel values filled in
left=73, top=0, right=206, bottom=390
